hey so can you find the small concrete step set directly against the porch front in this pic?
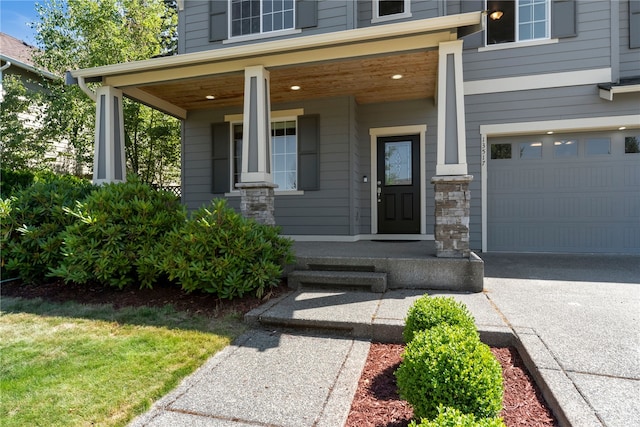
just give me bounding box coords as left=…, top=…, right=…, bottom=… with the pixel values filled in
left=288, top=270, right=387, bottom=293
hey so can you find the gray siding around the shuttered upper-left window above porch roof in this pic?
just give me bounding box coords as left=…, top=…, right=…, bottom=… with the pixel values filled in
left=178, top=0, right=355, bottom=53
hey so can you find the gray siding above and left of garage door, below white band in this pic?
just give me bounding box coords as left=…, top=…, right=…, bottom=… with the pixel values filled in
left=465, top=85, right=638, bottom=250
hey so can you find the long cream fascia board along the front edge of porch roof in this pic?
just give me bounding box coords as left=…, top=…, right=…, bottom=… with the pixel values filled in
left=70, top=12, right=482, bottom=78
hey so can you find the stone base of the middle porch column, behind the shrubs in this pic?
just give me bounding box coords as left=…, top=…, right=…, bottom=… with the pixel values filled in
left=236, top=182, right=278, bottom=225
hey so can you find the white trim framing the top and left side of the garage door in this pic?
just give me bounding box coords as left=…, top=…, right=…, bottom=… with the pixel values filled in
left=480, top=114, right=640, bottom=252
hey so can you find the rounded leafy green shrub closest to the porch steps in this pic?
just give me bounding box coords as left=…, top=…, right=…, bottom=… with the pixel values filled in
left=159, top=200, right=292, bottom=298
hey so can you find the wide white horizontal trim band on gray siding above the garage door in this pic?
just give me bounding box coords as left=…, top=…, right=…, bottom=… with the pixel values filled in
left=464, top=68, right=611, bottom=95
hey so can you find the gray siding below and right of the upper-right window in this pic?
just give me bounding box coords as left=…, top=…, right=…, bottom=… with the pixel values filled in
left=464, top=1, right=611, bottom=80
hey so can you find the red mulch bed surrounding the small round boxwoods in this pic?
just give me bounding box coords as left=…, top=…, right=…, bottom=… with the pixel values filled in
left=346, top=343, right=558, bottom=427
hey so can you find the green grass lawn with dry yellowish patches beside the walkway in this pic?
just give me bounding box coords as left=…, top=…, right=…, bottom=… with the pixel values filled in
left=0, top=297, right=244, bottom=427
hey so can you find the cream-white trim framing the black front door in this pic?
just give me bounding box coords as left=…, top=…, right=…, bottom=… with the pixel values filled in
left=369, top=125, right=427, bottom=234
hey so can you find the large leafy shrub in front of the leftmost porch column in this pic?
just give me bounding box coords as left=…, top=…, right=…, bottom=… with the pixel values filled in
left=52, top=177, right=186, bottom=289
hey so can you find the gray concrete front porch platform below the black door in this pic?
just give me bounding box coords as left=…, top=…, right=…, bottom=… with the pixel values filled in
left=286, top=240, right=484, bottom=292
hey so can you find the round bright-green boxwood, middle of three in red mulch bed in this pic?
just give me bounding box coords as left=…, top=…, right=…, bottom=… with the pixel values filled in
left=395, top=324, right=503, bottom=419
